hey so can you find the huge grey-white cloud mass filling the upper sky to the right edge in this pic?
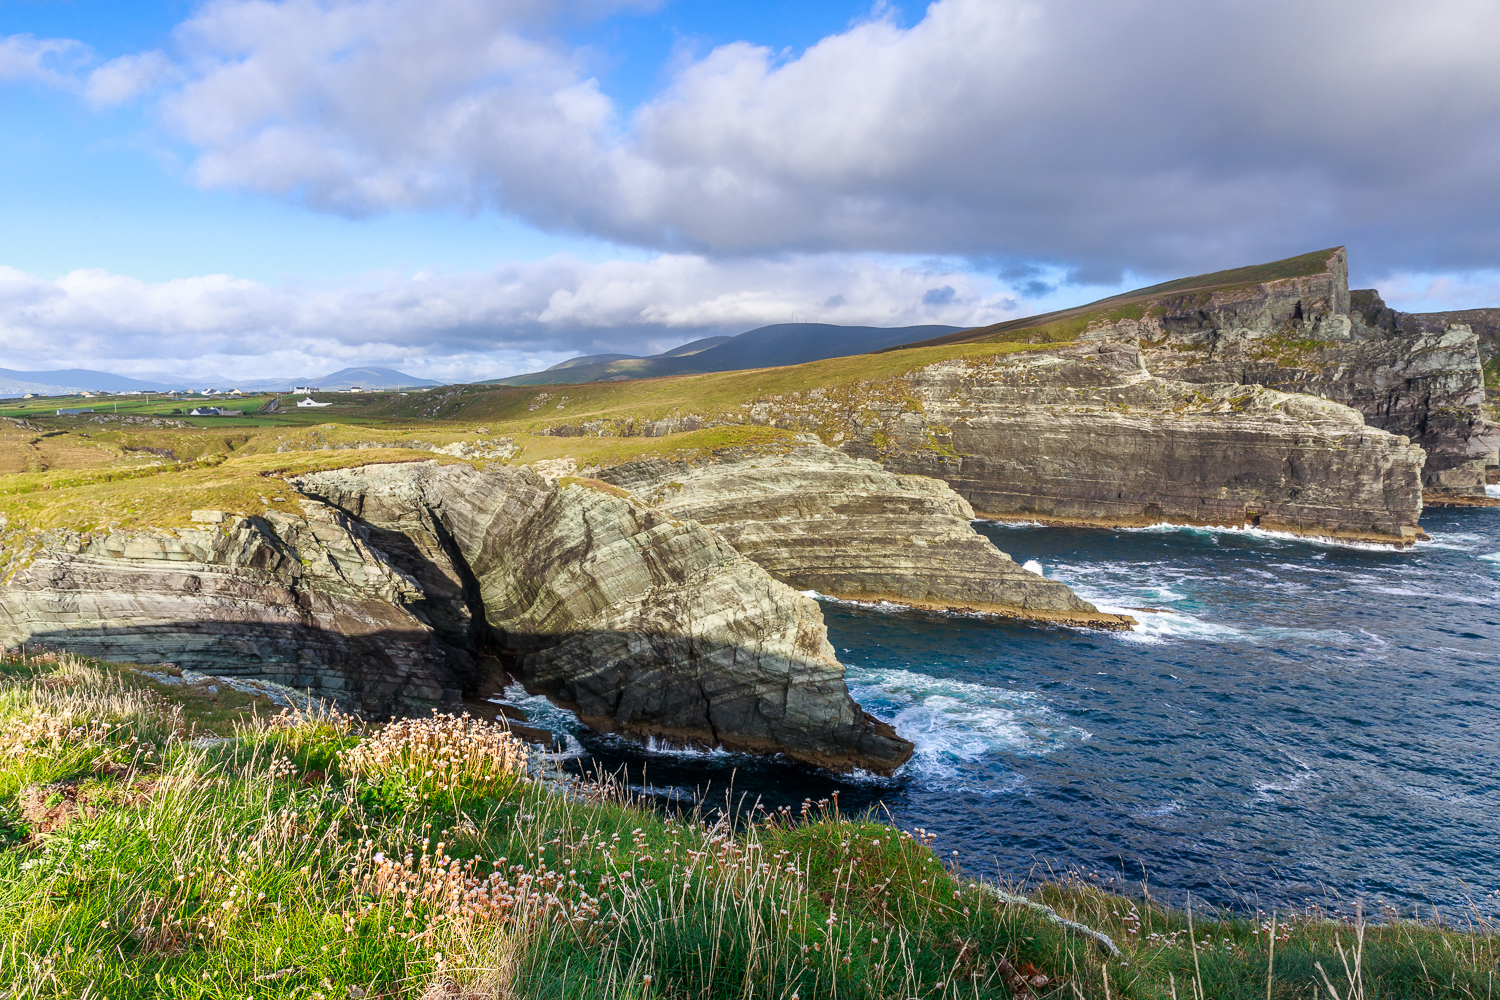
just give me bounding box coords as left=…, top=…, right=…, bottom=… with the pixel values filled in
left=138, top=0, right=1500, bottom=280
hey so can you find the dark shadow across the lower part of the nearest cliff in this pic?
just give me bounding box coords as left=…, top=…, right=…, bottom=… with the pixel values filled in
left=27, top=619, right=912, bottom=774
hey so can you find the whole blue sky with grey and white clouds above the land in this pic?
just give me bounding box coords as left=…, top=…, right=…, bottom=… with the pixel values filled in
left=0, top=0, right=1500, bottom=381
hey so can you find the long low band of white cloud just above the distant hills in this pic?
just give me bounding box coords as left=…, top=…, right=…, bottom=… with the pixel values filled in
left=0, top=255, right=1022, bottom=381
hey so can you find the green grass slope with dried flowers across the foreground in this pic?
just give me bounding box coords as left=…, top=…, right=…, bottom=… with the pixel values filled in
left=0, top=657, right=1500, bottom=1000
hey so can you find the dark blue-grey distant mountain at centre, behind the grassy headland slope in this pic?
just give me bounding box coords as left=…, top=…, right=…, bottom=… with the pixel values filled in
left=489, top=322, right=960, bottom=385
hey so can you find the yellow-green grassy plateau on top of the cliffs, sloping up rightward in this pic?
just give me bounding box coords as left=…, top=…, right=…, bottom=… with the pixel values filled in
left=0, top=334, right=1056, bottom=531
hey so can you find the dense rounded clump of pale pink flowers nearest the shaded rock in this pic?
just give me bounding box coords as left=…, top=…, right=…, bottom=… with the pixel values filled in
left=339, top=714, right=527, bottom=801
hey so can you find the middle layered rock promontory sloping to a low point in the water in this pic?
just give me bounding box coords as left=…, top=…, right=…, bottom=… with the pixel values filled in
left=596, top=436, right=1130, bottom=628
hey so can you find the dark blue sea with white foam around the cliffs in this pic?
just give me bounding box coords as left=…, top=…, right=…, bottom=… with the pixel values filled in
left=498, top=497, right=1500, bottom=916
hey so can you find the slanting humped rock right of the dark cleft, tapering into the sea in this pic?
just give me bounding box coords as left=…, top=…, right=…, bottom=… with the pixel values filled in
left=294, top=463, right=912, bottom=772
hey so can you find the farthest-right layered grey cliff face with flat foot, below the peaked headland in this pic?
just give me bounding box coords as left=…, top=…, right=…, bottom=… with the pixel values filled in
left=551, top=343, right=1425, bottom=544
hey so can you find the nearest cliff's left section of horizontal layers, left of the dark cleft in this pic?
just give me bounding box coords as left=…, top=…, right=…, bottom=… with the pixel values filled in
left=0, top=502, right=459, bottom=715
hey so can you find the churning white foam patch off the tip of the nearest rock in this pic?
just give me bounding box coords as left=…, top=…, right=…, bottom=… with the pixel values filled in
left=846, top=667, right=1089, bottom=780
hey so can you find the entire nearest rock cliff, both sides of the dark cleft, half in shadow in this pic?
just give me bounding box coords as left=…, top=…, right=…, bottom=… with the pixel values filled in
left=0, top=462, right=912, bottom=772
